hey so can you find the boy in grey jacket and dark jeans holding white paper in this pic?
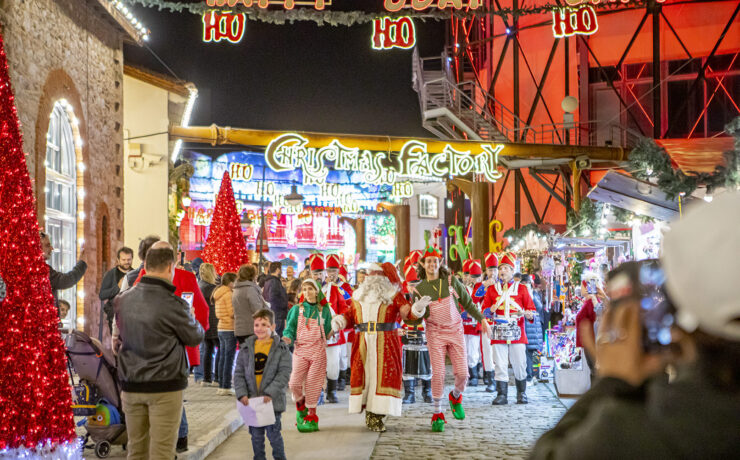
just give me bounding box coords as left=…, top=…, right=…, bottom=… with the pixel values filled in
left=234, top=309, right=292, bottom=460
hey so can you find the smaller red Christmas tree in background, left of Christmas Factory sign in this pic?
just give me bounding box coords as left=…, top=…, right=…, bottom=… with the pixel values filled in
left=203, top=172, right=249, bottom=274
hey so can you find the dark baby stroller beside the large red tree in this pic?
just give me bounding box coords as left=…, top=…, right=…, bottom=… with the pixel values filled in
left=66, top=331, right=128, bottom=458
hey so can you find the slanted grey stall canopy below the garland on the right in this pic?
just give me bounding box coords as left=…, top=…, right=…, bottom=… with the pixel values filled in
left=588, top=171, right=678, bottom=221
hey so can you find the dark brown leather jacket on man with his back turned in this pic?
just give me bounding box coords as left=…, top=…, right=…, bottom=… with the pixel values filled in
left=113, top=276, right=204, bottom=393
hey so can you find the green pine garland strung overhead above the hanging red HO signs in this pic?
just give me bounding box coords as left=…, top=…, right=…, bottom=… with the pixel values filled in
left=125, top=0, right=648, bottom=27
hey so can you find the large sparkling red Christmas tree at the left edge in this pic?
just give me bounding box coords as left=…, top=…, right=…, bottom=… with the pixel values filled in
left=0, top=36, right=80, bottom=458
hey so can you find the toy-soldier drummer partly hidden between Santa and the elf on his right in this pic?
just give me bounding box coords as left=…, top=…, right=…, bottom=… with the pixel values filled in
left=401, top=255, right=432, bottom=404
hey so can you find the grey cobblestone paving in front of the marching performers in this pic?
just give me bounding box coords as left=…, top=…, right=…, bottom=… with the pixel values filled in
left=371, top=366, right=565, bottom=460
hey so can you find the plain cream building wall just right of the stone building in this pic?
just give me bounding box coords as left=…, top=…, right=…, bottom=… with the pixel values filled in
left=123, top=76, right=169, bottom=266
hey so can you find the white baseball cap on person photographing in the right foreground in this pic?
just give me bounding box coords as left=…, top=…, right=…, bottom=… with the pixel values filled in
left=661, top=192, right=740, bottom=341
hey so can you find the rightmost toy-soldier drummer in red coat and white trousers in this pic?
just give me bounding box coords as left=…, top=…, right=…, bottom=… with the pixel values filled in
left=483, top=253, right=536, bottom=405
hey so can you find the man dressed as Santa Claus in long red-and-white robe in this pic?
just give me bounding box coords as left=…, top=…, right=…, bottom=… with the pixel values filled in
left=332, top=262, right=410, bottom=432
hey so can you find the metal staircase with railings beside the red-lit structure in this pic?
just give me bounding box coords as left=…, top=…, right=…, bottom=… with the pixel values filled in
left=412, top=48, right=536, bottom=142
